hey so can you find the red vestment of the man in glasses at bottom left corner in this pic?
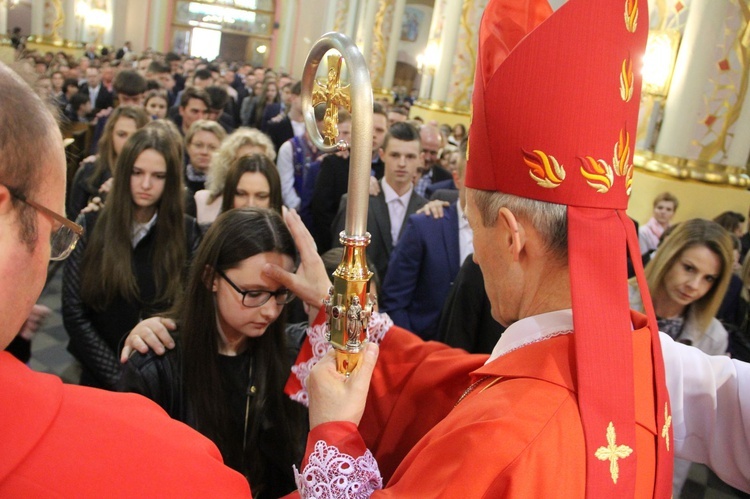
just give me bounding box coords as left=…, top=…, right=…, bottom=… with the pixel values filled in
left=0, top=352, right=250, bottom=497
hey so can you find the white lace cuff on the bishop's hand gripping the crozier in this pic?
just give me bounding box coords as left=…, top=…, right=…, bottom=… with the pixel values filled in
left=294, top=440, right=383, bottom=499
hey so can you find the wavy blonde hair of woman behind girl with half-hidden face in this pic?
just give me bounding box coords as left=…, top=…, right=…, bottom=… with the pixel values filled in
left=195, top=127, right=276, bottom=226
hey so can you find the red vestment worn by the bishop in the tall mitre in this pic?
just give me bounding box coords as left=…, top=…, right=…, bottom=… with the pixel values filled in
left=294, top=314, right=661, bottom=498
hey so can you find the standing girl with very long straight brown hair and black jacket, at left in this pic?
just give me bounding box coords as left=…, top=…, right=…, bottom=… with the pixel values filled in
left=62, top=125, right=200, bottom=389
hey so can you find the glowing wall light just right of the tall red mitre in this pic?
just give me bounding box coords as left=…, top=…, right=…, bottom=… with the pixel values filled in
left=643, top=30, right=680, bottom=98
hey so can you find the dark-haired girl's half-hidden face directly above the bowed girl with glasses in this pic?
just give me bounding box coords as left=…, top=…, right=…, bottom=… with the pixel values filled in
left=221, top=154, right=282, bottom=214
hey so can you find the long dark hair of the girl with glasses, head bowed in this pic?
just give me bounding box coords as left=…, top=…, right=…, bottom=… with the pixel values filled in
left=181, top=208, right=304, bottom=496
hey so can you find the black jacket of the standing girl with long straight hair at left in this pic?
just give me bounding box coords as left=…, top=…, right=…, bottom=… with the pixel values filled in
left=62, top=213, right=201, bottom=390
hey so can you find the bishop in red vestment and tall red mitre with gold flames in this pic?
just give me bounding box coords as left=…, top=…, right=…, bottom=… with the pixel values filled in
left=288, top=0, right=673, bottom=498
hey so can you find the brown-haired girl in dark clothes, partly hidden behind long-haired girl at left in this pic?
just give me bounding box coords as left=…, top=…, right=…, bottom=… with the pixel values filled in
left=66, top=106, right=151, bottom=220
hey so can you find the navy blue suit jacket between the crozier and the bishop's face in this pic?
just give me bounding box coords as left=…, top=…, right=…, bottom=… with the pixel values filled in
left=381, top=203, right=461, bottom=340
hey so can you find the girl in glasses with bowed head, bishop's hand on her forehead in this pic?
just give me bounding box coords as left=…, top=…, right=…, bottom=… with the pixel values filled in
left=119, top=208, right=329, bottom=498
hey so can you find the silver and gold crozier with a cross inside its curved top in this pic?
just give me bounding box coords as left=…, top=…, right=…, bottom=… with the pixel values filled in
left=300, top=33, right=375, bottom=375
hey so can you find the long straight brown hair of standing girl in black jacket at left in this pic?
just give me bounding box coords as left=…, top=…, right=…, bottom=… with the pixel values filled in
left=81, top=126, right=187, bottom=310
